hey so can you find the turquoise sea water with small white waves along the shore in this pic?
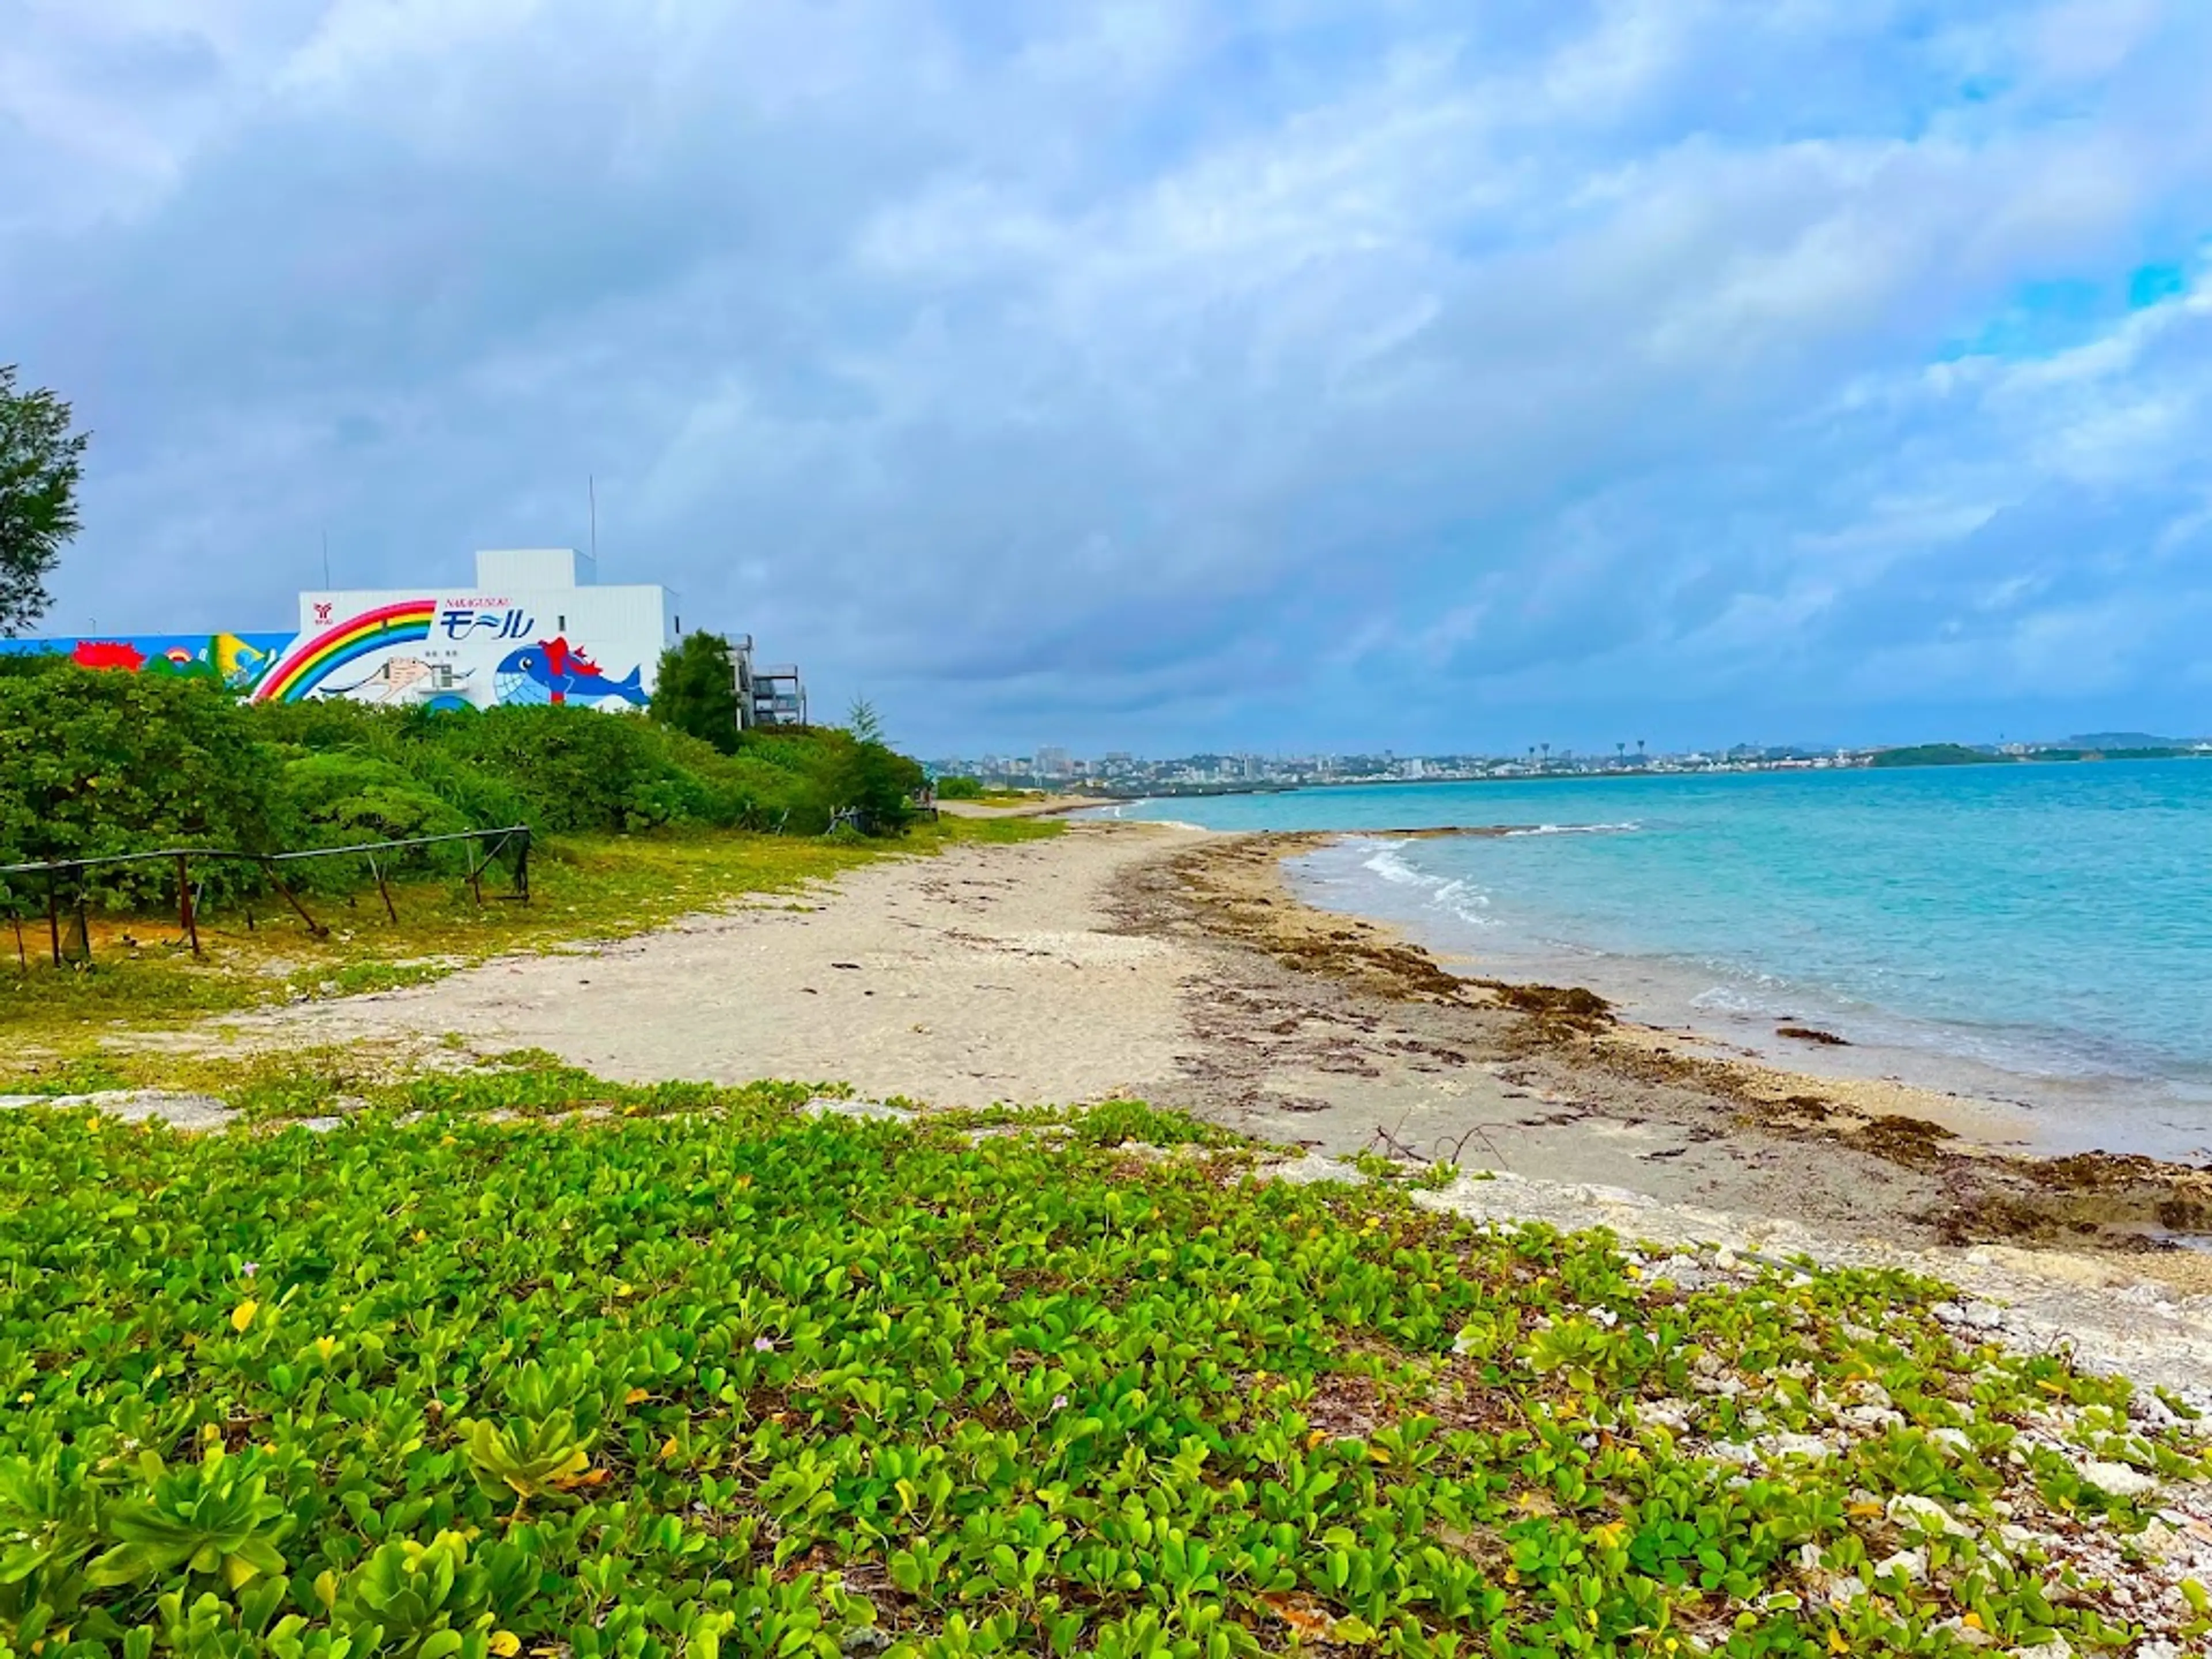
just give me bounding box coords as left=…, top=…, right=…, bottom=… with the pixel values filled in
left=1115, top=761, right=2212, bottom=1159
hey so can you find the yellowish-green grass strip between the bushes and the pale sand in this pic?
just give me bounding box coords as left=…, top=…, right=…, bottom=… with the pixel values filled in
left=0, top=819, right=1059, bottom=1071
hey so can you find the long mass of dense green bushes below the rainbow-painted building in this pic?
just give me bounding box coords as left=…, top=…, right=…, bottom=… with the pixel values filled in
left=0, top=659, right=922, bottom=909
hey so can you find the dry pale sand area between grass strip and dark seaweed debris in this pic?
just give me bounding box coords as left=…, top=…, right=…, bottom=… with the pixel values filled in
left=232, top=825, right=1195, bottom=1106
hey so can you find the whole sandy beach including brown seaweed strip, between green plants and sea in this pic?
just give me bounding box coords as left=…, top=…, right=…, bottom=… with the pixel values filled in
left=181, top=823, right=2212, bottom=1382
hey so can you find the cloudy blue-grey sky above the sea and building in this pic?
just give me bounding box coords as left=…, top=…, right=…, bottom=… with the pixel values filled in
left=0, top=0, right=2212, bottom=754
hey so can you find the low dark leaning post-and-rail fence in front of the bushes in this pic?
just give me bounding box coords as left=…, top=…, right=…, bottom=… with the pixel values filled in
left=0, top=823, right=531, bottom=974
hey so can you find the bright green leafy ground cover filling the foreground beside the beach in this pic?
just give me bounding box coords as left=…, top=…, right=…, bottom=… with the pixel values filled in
left=0, top=1079, right=2212, bottom=1659
